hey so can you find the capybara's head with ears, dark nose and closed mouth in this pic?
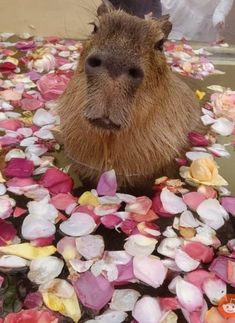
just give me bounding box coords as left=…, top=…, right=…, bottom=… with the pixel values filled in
left=70, top=1, right=171, bottom=132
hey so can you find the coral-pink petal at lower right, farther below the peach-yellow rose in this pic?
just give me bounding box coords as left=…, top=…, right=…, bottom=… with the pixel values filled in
left=182, top=242, right=214, bottom=263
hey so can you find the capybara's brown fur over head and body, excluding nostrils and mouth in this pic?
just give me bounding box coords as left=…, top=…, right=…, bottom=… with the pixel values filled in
left=59, top=6, right=200, bottom=190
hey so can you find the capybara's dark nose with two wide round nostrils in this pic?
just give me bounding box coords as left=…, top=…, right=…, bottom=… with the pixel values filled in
left=85, top=52, right=144, bottom=84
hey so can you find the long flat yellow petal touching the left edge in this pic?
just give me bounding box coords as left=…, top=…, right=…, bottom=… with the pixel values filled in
left=0, top=243, right=56, bottom=260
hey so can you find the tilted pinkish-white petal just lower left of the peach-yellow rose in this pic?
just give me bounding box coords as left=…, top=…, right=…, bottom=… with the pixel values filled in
left=160, top=189, right=187, bottom=214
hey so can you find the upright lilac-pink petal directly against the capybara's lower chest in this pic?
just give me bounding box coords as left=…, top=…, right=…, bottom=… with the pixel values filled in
left=97, top=170, right=117, bottom=196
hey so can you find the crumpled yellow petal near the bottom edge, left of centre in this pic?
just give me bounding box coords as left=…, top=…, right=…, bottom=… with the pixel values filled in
left=42, top=292, right=81, bottom=322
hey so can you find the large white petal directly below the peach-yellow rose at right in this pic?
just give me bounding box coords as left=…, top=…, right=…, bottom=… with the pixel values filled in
left=197, top=199, right=229, bottom=230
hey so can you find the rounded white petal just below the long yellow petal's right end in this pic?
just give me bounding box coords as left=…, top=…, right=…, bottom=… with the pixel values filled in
left=28, top=256, right=64, bottom=285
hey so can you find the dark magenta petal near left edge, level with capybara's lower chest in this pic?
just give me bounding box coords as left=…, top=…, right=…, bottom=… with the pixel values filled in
left=5, top=158, right=34, bottom=178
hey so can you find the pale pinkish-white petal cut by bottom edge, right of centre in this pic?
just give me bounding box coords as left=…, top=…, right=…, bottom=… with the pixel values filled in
left=132, top=296, right=162, bottom=323
